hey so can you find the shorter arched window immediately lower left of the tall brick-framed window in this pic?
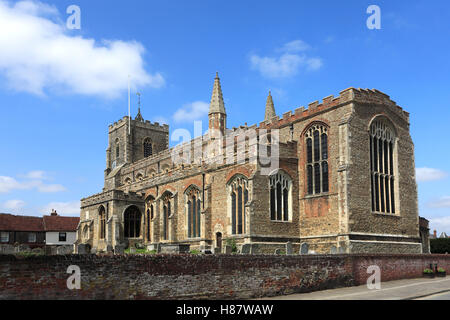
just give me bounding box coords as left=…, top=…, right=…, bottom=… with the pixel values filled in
left=269, top=171, right=292, bottom=221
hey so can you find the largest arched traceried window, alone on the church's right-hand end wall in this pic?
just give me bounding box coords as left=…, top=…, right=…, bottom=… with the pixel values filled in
left=369, top=119, right=396, bottom=214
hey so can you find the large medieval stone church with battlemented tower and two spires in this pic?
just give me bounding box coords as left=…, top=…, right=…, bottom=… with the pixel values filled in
left=77, top=75, right=422, bottom=254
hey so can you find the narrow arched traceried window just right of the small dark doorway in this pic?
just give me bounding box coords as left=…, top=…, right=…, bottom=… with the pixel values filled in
left=229, top=176, right=248, bottom=234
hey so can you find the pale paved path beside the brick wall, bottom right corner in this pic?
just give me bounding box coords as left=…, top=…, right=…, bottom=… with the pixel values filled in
left=258, top=277, right=450, bottom=300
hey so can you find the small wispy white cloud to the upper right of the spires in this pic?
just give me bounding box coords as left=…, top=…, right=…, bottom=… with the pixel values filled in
left=250, top=40, right=323, bottom=78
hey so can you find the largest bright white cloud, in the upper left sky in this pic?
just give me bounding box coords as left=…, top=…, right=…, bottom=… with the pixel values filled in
left=0, top=0, right=164, bottom=98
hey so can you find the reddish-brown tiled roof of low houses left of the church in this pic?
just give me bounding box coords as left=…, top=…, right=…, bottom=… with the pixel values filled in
left=0, top=213, right=80, bottom=232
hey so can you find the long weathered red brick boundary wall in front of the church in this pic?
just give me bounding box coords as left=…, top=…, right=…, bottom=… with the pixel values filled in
left=0, top=255, right=450, bottom=299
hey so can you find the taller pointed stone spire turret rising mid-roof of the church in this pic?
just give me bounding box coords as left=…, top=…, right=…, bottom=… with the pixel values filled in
left=208, top=72, right=227, bottom=136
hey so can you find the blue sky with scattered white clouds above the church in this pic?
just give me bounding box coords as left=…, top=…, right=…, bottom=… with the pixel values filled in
left=0, top=0, right=450, bottom=234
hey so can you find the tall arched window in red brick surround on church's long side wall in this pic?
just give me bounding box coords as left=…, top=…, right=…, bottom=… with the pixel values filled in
left=305, top=124, right=329, bottom=195
